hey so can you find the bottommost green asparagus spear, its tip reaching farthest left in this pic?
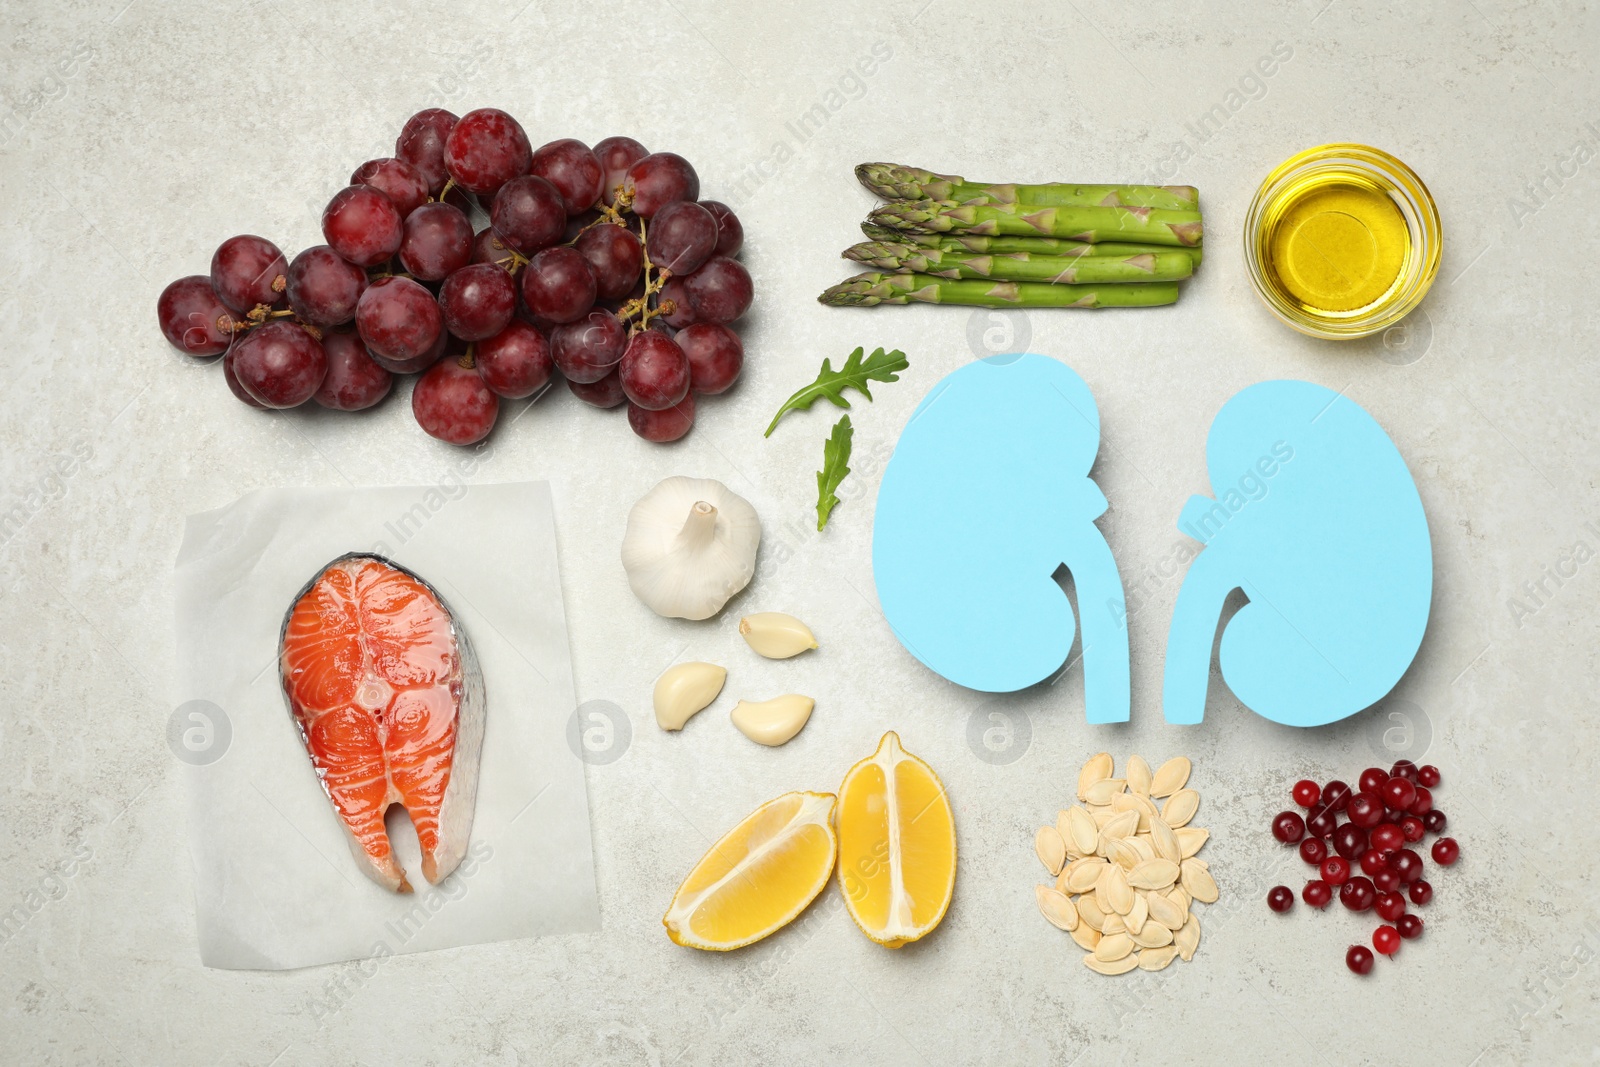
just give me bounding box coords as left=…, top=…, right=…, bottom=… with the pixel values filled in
left=818, top=274, right=1178, bottom=307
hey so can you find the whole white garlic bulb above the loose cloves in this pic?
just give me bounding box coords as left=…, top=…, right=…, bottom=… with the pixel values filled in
left=622, top=477, right=762, bottom=619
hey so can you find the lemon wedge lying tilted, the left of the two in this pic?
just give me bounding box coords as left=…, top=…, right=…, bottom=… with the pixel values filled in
left=661, top=792, right=838, bottom=952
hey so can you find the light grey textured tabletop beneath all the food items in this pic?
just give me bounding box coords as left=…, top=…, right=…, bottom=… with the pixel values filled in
left=0, top=0, right=1600, bottom=1067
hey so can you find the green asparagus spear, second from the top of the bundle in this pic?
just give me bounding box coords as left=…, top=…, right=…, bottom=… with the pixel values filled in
left=867, top=200, right=1205, bottom=248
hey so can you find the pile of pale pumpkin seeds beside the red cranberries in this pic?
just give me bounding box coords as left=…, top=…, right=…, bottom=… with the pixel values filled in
left=1034, top=752, right=1218, bottom=974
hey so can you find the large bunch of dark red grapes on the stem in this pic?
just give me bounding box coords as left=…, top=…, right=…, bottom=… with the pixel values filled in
left=157, top=107, right=752, bottom=445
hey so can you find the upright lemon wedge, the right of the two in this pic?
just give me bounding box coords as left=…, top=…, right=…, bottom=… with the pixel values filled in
left=838, top=729, right=955, bottom=949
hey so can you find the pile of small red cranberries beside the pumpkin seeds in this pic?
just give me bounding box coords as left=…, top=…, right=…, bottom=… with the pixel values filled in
left=1267, top=760, right=1461, bottom=974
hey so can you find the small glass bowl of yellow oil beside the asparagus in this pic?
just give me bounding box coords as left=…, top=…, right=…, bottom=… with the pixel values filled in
left=1245, top=144, right=1443, bottom=341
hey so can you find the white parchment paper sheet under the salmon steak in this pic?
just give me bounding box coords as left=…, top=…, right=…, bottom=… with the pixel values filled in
left=174, top=482, right=600, bottom=969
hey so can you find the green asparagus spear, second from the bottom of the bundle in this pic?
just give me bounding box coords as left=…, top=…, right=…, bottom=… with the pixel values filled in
left=845, top=242, right=1194, bottom=285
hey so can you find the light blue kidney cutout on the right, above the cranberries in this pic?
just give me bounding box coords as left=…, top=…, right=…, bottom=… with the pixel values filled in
left=1162, top=381, right=1434, bottom=726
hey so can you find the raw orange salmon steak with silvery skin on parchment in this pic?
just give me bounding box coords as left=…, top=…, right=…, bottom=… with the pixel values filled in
left=278, top=552, right=485, bottom=893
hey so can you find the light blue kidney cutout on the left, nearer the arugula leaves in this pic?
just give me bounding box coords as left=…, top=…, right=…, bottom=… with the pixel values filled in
left=872, top=354, right=1130, bottom=723
